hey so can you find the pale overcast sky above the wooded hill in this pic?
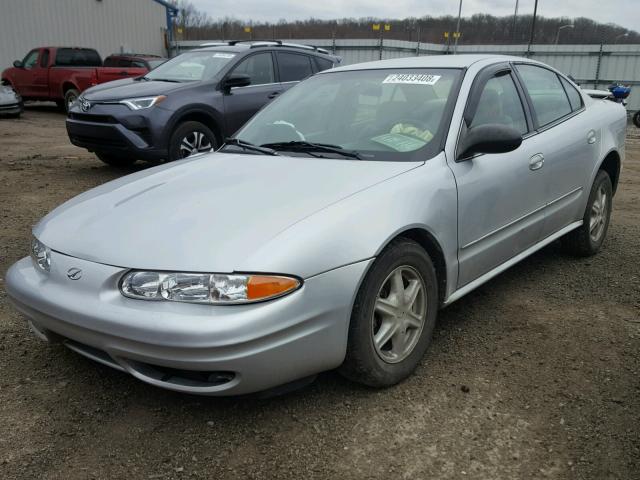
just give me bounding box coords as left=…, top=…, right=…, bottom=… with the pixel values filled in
left=191, top=0, right=640, bottom=31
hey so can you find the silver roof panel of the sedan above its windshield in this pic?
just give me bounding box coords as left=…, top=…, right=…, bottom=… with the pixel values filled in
left=331, top=54, right=536, bottom=72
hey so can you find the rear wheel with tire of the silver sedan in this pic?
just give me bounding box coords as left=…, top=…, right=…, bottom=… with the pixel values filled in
left=562, top=170, right=613, bottom=257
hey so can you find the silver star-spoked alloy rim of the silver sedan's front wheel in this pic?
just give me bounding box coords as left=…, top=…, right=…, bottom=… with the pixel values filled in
left=372, top=265, right=427, bottom=363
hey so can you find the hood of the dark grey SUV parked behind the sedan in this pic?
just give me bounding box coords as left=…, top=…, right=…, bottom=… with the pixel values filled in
left=82, top=78, right=191, bottom=102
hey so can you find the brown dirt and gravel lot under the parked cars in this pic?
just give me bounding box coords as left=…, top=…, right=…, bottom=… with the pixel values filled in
left=0, top=107, right=640, bottom=480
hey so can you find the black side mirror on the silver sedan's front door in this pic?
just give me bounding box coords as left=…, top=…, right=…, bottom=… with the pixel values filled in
left=456, top=124, right=522, bottom=162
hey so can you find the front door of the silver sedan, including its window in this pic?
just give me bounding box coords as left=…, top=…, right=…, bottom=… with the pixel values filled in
left=449, top=64, right=547, bottom=288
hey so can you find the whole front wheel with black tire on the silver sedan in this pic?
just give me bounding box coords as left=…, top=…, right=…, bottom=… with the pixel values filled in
left=339, top=239, right=439, bottom=388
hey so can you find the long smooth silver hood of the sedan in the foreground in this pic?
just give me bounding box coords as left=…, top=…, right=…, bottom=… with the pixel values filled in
left=34, top=153, right=422, bottom=274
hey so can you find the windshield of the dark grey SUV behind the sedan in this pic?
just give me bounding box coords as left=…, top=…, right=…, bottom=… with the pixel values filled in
left=145, top=51, right=236, bottom=82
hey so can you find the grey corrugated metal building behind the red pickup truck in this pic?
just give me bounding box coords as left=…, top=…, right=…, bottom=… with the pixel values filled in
left=0, top=0, right=175, bottom=70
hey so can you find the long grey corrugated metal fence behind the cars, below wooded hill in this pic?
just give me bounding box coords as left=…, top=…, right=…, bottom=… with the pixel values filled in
left=171, top=39, right=640, bottom=110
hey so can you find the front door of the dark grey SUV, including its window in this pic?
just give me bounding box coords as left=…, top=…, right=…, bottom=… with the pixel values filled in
left=224, top=52, right=282, bottom=135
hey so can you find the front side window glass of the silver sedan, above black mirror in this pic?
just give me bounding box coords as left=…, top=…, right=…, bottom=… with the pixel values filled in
left=470, top=75, right=528, bottom=134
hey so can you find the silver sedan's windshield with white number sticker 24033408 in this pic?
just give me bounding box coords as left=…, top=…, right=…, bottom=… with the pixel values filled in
left=236, top=69, right=460, bottom=161
